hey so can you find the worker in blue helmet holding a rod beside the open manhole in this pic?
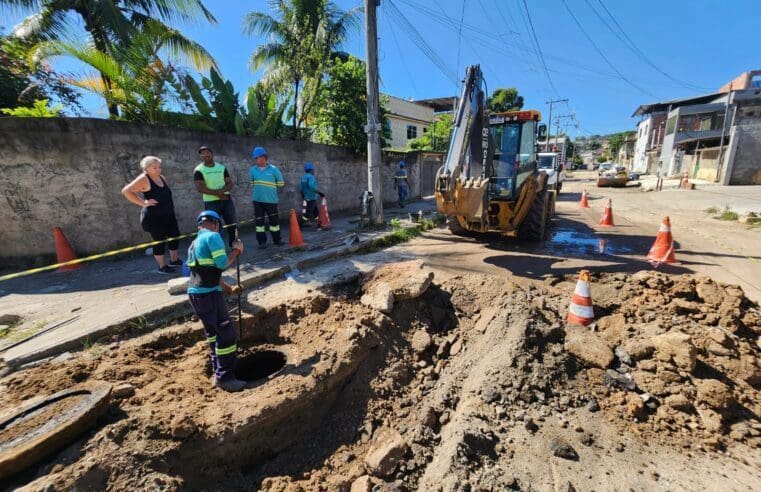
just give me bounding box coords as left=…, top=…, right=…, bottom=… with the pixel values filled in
left=187, top=210, right=246, bottom=392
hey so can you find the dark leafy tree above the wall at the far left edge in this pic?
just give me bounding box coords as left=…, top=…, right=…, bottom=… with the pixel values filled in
left=0, top=30, right=82, bottom=113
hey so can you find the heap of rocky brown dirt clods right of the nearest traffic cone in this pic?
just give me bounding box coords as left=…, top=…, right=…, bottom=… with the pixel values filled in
left=566, top=272, right=761, bottom=448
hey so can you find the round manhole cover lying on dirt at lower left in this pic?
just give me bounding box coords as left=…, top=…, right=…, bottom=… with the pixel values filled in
left=0, top=383, right=111, bottom=478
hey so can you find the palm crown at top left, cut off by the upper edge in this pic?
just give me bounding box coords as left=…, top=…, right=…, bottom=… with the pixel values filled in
left=0, top=0, right=216, bottom=116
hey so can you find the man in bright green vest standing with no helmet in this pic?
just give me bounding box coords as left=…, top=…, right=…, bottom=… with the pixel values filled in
left=193, top=146, right=237, bottom=247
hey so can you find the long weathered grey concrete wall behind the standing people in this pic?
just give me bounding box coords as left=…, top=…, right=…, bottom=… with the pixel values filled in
left=0, top=118, right=428, bottom=262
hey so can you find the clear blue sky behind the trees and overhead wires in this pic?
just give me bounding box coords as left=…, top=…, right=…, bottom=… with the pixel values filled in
left=0, top=0, right=761, bottom=136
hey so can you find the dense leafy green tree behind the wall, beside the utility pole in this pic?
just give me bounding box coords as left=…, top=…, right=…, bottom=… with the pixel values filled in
left=314, top=56, right=391, bottom=154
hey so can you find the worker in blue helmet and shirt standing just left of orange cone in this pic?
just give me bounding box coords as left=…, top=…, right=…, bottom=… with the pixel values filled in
left=248, top=147, right=285, bottom=248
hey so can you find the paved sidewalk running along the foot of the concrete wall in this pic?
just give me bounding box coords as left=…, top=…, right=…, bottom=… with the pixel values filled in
left=0, top=199, right=436, bottom=366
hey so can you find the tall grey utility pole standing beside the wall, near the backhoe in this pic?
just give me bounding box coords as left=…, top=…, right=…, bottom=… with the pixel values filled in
left=365, top=0, right=383, bottom=224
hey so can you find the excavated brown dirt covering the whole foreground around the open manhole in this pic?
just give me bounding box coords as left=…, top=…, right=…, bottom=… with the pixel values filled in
left=0, top=263, right=761, bottom=491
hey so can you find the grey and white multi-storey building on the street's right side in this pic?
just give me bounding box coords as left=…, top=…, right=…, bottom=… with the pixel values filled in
left=632, top=76, right=761, bottom=184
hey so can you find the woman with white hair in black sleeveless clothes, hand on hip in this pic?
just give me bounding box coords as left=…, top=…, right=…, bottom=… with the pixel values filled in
left=122, top=155, right=182, bottom=274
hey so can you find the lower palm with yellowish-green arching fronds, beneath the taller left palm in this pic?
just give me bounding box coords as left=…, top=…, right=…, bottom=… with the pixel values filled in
left=35, top=20, right=216, bottom=124
